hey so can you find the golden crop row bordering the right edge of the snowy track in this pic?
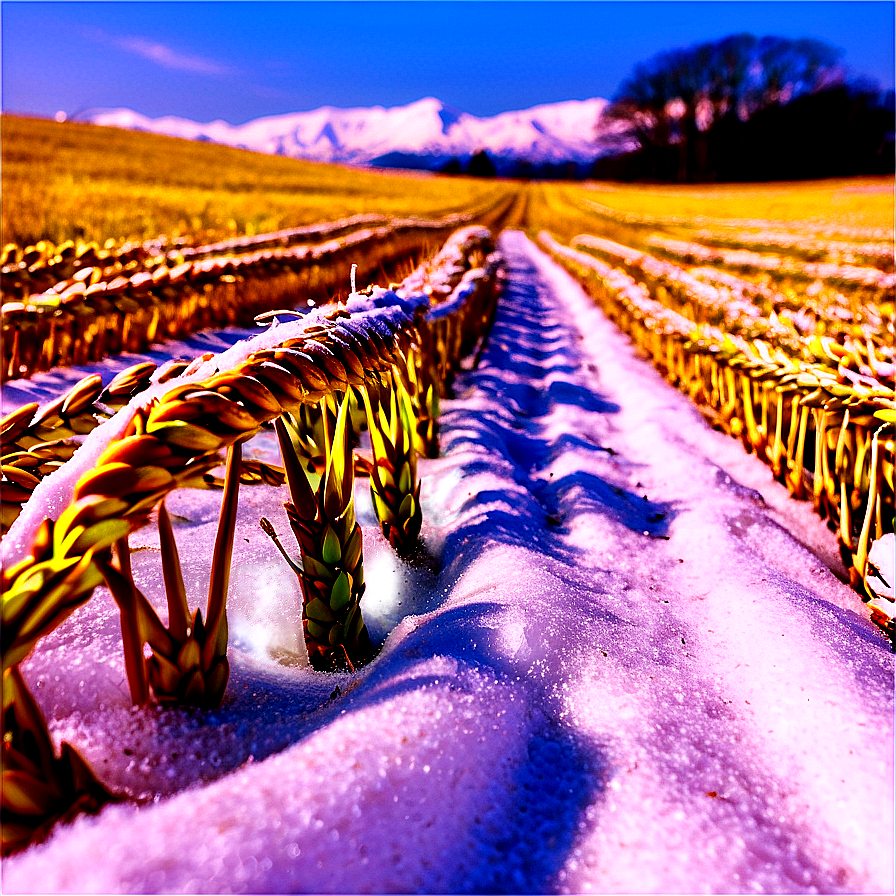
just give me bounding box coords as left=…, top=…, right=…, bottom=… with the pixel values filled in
left=539, top=233, right=896, bottom=635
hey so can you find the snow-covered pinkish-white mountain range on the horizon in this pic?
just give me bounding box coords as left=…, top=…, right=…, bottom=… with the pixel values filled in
left=81, top=97, right=607, bottom=168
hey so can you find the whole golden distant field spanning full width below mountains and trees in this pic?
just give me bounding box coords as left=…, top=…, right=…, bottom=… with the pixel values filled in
left=0, top=115, right=894, bottom=252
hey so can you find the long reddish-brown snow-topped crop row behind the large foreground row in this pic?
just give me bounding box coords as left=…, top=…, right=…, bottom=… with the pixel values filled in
left=0, top=216, right=490, bottom=379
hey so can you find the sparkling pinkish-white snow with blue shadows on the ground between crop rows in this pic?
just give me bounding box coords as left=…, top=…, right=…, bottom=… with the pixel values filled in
left=3, top=233, right=894, bottom=893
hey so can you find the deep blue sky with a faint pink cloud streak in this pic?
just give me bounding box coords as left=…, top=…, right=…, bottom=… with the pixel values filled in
left=0, top=0, right=896, bottom=123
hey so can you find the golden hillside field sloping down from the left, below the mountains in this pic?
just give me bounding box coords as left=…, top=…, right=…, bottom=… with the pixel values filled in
left=0, top=115, right=506, bottom=245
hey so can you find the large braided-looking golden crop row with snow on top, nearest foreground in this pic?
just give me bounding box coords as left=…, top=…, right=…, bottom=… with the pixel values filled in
left=0, top=228, right=503, bottom=853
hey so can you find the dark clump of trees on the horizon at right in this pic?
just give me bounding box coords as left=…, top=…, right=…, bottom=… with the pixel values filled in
left=590, top=34, right=896, bottom=182
